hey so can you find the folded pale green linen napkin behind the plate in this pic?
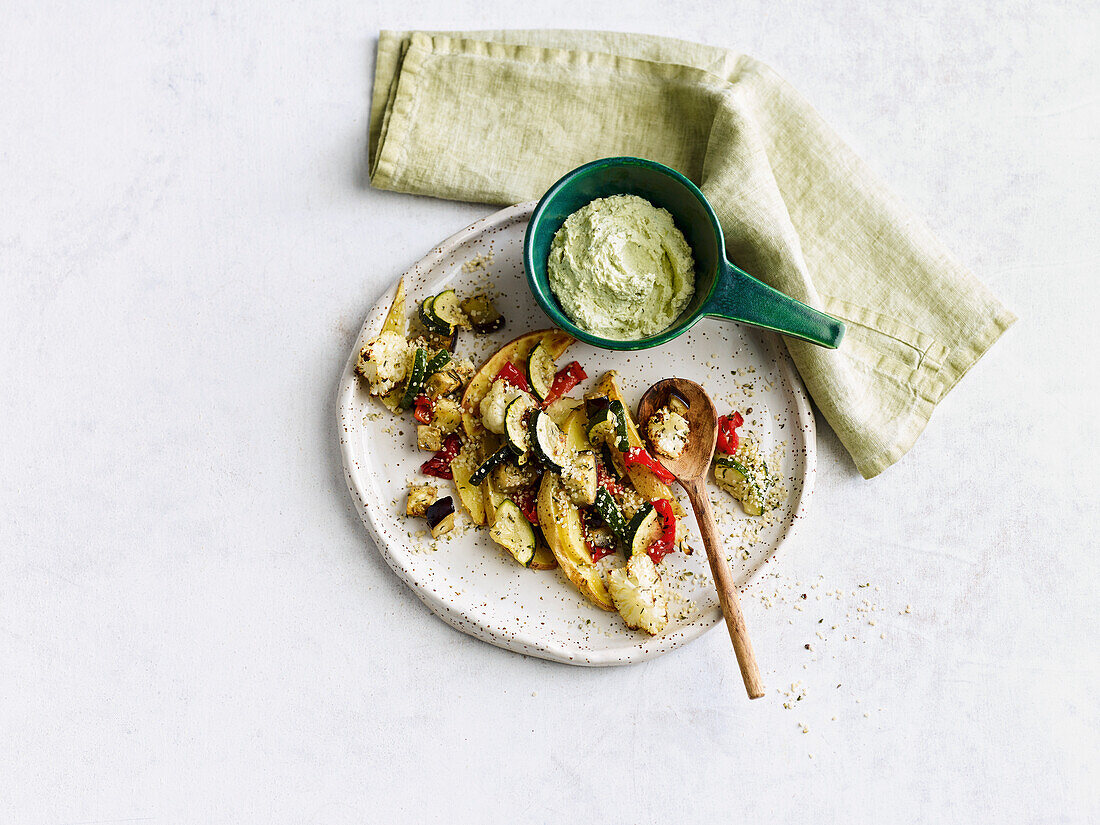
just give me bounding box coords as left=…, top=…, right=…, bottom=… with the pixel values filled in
left=369, top=31, right=1015, bottom=479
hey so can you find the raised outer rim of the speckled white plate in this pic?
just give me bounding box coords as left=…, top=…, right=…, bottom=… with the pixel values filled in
left=337, top=200, right=817, bottom=667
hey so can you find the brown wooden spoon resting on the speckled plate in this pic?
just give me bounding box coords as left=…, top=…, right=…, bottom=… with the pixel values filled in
left=638, top=378, right=763, bottom=699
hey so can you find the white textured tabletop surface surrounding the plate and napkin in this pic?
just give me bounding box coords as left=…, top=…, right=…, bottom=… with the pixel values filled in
left=0, top=0, right=1100, bottom=824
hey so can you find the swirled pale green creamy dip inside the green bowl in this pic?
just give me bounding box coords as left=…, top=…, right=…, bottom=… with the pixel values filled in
left=547, top=195, right=695, bottom=340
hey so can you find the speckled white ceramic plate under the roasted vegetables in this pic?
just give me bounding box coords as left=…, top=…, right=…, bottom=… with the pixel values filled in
left=338, top=202, right=815, bottom=666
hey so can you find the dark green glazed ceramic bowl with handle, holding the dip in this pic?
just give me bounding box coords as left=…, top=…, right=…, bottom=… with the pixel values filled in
left=524, top=157, right=844, bottom=350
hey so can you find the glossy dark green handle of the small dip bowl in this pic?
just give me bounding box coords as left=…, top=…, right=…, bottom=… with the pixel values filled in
left=703, top=257, right=844, bottom=350
